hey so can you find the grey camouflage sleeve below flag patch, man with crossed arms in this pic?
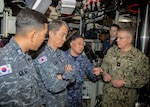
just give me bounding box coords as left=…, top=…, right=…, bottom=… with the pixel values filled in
left=35, top=58, right=74, bottom=93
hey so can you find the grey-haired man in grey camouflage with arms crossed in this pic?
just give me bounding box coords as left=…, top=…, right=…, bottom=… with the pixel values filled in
left=35, top=20, right=75, bottom=107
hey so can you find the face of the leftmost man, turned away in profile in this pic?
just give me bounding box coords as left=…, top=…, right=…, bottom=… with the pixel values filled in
left=32, top=24, right=48, bottom=51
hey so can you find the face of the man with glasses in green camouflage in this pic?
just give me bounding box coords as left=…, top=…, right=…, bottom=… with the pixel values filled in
left=117, top=31, right=132, bottom=49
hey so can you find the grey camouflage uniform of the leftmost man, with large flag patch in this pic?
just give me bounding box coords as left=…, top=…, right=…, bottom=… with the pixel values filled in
left=0, top=38, right=42, bottom=107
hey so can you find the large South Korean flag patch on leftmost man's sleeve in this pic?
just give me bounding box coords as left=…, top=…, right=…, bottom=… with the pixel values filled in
left=0, top=64, right=12, bottom=76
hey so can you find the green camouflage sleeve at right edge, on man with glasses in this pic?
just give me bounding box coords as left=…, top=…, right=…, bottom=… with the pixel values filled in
left=124, top=55, right=150, bottom=88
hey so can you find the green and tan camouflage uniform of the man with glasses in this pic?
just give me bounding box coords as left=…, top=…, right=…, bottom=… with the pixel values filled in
left=101, top=46, right=150, bottom=107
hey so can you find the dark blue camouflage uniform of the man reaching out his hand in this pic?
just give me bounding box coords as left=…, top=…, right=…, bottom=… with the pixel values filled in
left=66, top=49, right=96, bottom=107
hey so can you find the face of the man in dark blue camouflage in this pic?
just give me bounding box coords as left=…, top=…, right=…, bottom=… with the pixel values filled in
left=70, top=38, right=84, bottom=55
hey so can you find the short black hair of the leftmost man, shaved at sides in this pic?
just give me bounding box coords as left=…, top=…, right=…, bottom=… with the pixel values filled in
left=16, top=8, right=48, bottom=34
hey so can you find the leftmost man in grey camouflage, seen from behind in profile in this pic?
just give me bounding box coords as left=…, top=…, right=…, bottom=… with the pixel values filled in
left=0, top=9, right=48, bottom=107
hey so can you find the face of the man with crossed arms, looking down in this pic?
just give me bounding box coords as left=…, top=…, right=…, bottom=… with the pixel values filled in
left=50, top=25, right=68, bottom=48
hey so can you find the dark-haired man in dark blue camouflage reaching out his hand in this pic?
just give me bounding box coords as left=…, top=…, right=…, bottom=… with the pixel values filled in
left=66, top=33, right=101, bottom=107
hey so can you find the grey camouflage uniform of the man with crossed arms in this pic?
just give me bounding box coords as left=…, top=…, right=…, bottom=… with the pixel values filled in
left=35, top=45, right=75, bottom=107
